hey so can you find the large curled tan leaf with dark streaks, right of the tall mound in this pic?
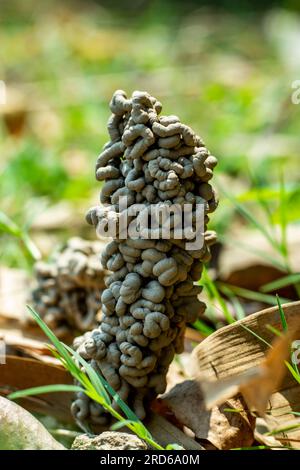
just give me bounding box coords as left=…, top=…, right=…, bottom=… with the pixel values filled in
left=193, top=302, right=300, bottom=447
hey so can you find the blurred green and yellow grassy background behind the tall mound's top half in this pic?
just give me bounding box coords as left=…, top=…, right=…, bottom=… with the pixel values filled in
left=0, top=0, right=300, bottom=274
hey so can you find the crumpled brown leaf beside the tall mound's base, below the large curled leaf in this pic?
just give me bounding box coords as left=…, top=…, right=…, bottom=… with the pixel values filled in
left=159, top=380, right=255, bottom=450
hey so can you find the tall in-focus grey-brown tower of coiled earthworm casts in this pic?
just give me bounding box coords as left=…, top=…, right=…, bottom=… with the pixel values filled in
left=72, top=90, right=217, bottom=424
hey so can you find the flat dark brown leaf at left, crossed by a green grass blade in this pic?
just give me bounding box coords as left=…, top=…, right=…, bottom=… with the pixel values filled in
left=0, top=356, right=73, bottom=422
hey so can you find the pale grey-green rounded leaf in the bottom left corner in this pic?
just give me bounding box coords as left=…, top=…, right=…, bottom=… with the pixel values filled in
left=0, top=397, right=65, bottom=450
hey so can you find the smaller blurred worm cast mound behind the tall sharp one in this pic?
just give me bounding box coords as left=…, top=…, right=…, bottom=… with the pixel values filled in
left=28, top=238, right=107, bottom=340
